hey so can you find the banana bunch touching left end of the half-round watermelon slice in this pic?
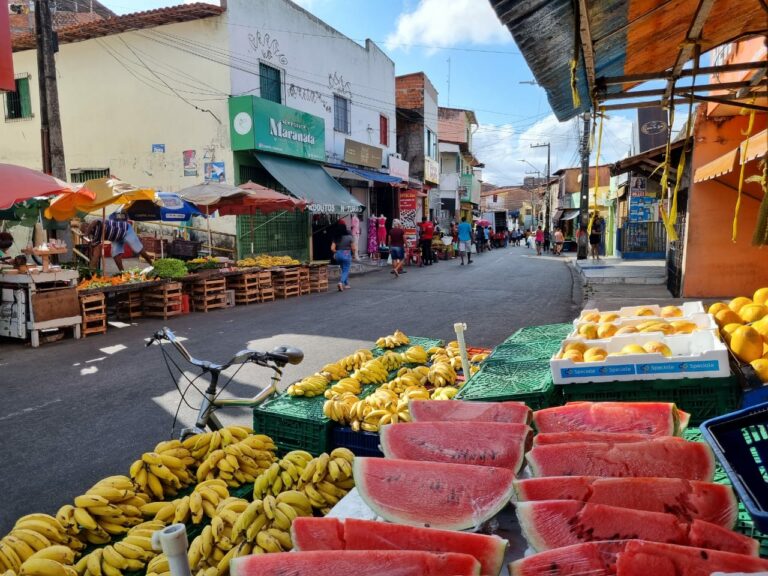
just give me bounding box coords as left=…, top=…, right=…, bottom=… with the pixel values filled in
left=298, top=448, right=355, bottom=515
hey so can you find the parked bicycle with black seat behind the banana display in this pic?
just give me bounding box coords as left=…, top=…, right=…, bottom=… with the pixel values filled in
left=147, top=327, right=304, bottom=440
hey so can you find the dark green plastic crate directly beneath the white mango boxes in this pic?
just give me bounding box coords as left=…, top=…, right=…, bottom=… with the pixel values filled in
left=555, top=376, right=740, bottom=424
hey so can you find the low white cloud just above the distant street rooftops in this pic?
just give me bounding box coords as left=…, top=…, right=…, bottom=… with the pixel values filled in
left=472, top=114, right=632, bottom=185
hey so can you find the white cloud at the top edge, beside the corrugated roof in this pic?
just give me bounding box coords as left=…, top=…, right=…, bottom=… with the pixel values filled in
left=386, top=0, right=512, bottom=50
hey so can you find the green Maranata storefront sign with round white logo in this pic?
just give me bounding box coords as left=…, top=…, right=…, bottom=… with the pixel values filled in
left=229, top=96, right=325, bottom=162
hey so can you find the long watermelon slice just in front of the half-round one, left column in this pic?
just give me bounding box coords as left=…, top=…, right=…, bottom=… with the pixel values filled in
left=291, top=517, right=507, bottom=576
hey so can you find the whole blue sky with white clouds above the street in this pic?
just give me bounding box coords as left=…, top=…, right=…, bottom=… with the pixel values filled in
left=101, top=0, right=635, bottom=185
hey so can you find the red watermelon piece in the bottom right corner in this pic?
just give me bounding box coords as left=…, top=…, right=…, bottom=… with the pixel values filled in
left=617, top=540, right=768, bottom=576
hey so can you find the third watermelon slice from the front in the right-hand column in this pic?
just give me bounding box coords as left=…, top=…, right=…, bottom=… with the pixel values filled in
left=515, top=476, right=739, bottom=528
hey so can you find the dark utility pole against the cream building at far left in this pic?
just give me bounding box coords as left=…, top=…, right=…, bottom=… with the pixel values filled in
left=35, top=0, right=67, bottom=180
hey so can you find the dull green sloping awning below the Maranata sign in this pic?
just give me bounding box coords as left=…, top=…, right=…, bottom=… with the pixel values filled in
left=255, top=152, right=362, bottom=214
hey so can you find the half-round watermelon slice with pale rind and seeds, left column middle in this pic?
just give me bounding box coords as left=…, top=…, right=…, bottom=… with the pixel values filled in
left=353, top=456, right=515, bottom=530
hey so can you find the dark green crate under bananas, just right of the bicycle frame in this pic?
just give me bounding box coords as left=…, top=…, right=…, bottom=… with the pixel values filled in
left=253, top=392, right=332, bottom=456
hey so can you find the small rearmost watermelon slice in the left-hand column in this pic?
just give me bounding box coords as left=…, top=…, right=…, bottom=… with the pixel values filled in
left=408, top=400, right=531, bottom=424
